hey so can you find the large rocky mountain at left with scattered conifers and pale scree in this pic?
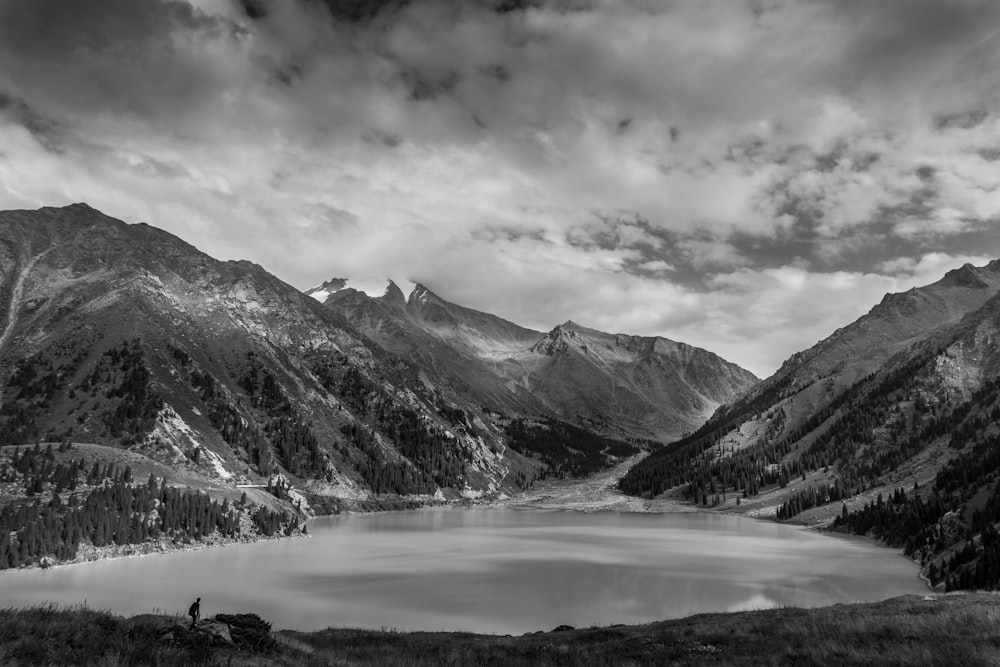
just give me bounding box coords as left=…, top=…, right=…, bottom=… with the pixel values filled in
left=0, top=204, right=540, bottom=512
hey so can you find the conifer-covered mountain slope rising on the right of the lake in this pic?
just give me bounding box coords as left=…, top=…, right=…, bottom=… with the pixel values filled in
left=620, top=261, right=1000, bottom=588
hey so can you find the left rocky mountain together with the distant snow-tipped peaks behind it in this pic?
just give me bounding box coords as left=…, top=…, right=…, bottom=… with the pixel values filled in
left=0, top=204, right=756, bottom=516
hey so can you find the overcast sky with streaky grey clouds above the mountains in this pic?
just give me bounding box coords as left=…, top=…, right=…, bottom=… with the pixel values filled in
left=0, top=0, right=1000, bottom=377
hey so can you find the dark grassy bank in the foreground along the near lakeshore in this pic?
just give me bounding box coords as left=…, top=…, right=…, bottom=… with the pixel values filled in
left=0, top=593, right=1000, bottom=666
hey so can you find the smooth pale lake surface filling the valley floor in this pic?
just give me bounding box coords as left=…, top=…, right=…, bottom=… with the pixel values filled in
left=0, top=508, right=926, bottom=634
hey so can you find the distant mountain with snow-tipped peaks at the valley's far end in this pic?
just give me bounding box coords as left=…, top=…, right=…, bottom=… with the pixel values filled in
left=310, top=282, right=757, bottom=439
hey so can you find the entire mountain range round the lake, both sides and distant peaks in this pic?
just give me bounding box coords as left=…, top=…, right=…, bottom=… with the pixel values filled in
left=0, top=204, right=1000, bottom=588
